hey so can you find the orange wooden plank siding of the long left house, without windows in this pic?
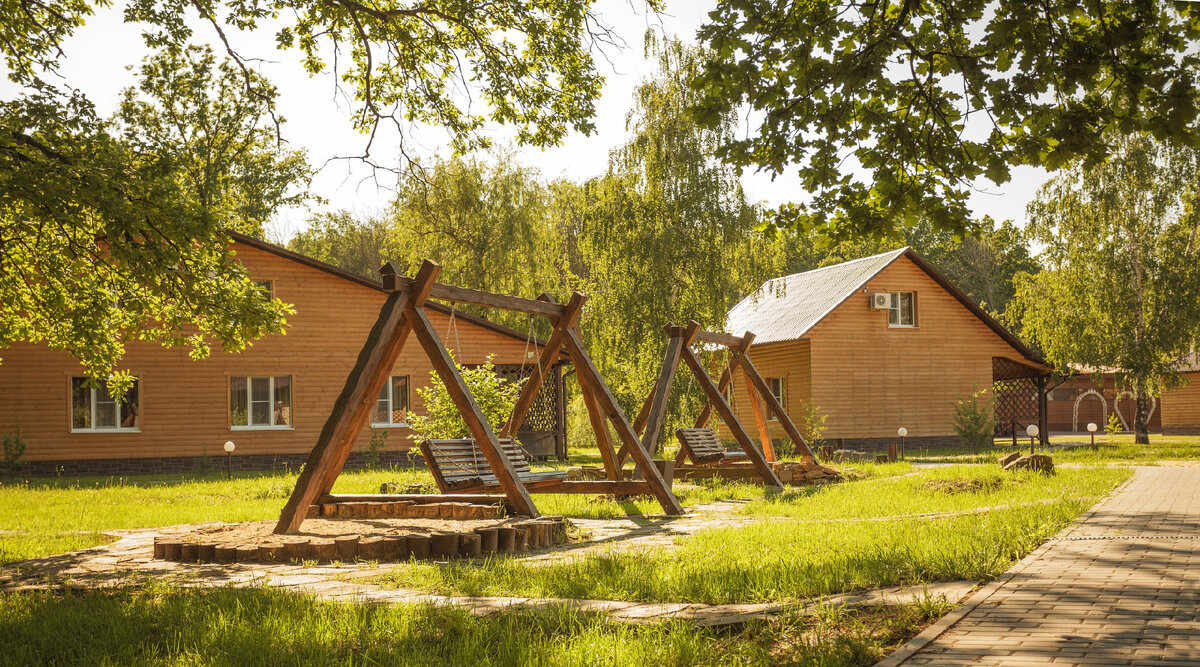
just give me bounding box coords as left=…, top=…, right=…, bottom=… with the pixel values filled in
left=0, top=244, right=536, bottom=461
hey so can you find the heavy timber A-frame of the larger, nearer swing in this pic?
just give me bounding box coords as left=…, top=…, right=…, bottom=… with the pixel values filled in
left=275, top=260, right=683, bottom=534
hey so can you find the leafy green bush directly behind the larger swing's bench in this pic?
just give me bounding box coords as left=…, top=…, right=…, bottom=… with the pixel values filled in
left=408, top=356, right=524, bottom=441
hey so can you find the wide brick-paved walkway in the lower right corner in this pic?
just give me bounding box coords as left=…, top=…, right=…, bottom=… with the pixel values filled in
left=881, top=467, right=1200, bottom=666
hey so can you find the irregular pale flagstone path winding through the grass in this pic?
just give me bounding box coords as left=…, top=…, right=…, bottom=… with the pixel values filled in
left=0, top=501, right=977, bottom=625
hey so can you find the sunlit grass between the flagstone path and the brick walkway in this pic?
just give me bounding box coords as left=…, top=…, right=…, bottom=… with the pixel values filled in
left=379, top=467, right=1132, bottom=603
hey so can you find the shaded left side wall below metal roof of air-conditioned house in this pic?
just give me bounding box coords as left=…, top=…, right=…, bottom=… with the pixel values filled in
left=718, top=341, right=811, bottom=441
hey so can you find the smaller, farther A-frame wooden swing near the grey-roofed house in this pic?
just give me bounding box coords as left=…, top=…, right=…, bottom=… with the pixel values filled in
left=618, top=320, right=816, bottom=488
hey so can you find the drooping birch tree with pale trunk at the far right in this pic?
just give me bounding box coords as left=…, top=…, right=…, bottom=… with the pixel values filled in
left=1010, top=134, right=1200, bottom=444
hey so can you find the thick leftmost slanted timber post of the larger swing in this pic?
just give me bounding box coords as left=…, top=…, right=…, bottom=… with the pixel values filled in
left=275, top=264, right=438, bottom=533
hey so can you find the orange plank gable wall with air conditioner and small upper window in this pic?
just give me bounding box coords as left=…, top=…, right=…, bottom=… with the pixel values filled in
left=796, top=257, right=1028, bottom=439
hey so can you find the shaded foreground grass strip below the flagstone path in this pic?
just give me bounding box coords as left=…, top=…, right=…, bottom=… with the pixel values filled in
left=0, top=585, right=946, bottom=666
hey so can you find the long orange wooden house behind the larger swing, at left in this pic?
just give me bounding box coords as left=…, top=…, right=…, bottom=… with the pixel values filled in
left=0, top=233, right=566, bottom=475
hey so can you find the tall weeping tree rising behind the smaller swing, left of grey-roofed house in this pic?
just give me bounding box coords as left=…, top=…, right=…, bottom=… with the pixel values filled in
left=575, top=42, right=768, bottom=415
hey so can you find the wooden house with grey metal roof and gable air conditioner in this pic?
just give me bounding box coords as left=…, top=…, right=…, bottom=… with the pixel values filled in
left=726, top=248, right=1050, bottom=449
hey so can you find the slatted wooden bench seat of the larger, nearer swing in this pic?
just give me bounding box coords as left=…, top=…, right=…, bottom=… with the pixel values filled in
left=421, top=438, right=566, bottom=493
